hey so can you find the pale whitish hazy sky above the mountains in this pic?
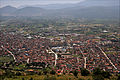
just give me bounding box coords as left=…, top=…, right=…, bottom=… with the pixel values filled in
left=0, top=0, right=84, bottom=7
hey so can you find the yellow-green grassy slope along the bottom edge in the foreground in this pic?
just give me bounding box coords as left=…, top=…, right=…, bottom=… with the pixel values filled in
left=2, top=74, right=92, bottom=80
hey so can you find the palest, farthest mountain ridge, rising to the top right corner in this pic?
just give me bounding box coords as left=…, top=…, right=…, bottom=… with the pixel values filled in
left=18, top=0, right=120, bottom=9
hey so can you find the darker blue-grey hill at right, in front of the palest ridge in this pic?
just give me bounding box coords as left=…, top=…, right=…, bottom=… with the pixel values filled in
left=60, top=6, right=119, bottom=19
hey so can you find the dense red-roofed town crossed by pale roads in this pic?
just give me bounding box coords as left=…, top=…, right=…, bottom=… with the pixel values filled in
left=0, top=28, right=120, bottom=72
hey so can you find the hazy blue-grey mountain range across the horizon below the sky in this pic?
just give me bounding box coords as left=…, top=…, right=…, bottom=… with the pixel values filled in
left=0, top=0, right=120, bottom=19
